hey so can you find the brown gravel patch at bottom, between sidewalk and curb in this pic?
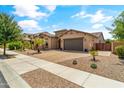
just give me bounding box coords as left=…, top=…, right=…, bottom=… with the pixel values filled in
left=21, top=69, right=81, bottom=88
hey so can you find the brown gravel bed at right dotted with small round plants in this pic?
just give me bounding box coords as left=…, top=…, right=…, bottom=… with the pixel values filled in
left=58, top=54, right=124, bottom=82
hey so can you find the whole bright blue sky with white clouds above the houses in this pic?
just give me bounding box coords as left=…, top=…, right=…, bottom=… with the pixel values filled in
left=0, top=5, right=124, bottom=39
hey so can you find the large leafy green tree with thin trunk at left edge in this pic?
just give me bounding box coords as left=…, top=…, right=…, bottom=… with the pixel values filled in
left=0, top=13, right=22, bottom=55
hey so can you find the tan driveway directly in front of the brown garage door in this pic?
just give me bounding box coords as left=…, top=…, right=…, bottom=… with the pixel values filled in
left=28, top=50, right=90, bottom=62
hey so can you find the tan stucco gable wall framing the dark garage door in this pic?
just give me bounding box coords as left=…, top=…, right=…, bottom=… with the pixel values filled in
left=60, top=31, right=97, bottom=49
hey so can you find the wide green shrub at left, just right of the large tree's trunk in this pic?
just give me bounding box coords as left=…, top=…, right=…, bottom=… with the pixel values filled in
left=8, top=41, right=23, bottom=50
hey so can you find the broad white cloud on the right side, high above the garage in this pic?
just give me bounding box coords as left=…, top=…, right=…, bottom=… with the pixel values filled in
left=72, top=10, right=112, bottom=23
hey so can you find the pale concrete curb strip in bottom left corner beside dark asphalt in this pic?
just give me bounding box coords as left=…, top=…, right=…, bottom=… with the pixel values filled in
left=0, top=62, right=31, bottom=88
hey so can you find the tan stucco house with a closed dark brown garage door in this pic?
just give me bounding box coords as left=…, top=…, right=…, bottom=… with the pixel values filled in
left=23, top=29, right=104, bottom=51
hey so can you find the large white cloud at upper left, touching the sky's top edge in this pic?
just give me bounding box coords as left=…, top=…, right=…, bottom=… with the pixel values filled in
left=13, top=5, right=48, bottom=18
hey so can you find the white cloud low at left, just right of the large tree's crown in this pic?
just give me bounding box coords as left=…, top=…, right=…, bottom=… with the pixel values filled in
left=18, top=20, right=42, bottom=31
